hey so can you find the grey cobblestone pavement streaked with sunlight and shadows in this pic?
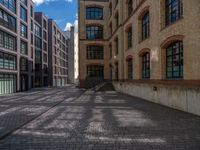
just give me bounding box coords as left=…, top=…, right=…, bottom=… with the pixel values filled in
left=0, top=87, right=200, bottom=150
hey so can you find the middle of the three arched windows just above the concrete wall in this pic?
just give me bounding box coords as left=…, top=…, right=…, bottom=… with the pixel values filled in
left=142, top=52, right=150, bottom=79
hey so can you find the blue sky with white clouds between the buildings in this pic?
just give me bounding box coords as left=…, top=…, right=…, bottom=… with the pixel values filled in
left=33, top=0, right=78, bottom=30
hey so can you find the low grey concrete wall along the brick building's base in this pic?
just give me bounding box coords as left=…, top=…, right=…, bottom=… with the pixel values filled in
left=113, top=82, right=200, bottom=115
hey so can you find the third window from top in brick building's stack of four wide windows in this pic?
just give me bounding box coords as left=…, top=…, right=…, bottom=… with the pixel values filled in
left=87, top=46, right=104, bottom=59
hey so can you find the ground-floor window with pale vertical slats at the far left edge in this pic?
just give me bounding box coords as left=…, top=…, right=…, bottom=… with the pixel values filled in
left=0, top=73, right=17, bottom=95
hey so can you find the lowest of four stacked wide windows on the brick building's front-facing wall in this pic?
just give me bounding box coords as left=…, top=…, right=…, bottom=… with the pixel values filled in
left=87, top=65, right=104, bottom=78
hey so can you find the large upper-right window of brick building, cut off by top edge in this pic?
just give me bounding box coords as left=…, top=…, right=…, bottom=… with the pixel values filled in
left=165, top=0, right=183, bottom=26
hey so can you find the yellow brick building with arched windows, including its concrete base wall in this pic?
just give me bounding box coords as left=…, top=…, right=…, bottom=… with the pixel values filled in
left=79, top=0, right=200, bottom=114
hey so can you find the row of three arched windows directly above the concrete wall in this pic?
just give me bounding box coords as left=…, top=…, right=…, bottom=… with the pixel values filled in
left=127, top=42, right=183, bottom=79
